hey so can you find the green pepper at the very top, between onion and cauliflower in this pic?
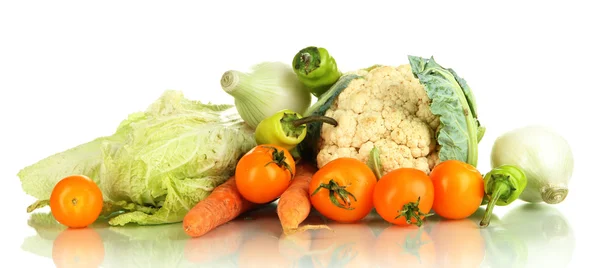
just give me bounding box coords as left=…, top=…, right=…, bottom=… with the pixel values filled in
left=292, top=46, right=342, bottom=98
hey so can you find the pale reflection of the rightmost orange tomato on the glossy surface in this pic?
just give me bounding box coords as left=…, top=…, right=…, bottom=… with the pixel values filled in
left=431, top=218, right=486, bottom=268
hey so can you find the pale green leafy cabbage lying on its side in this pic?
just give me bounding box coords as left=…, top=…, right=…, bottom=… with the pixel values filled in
left=18, top=91, right=256, bottom=225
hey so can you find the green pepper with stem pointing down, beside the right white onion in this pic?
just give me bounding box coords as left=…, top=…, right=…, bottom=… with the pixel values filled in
left=479, top=165, right=527, bottom=227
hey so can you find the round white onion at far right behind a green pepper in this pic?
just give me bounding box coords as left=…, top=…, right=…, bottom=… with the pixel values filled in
left=491, top=125, right=574, bottom=204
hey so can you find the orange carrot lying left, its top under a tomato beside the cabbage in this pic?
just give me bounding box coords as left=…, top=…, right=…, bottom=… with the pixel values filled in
left=183, top=177, right=255, bottom=237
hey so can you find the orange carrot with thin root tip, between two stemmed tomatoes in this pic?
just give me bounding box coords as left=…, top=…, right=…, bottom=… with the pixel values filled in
left=277, top=163, right=329, bottom=235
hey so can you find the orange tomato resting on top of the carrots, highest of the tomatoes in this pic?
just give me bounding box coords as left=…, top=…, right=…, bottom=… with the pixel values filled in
left=235, top=144, right=296, bottom=204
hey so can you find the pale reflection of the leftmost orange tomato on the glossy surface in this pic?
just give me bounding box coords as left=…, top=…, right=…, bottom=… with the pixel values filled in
left=52, top=228, right=105, bottom=268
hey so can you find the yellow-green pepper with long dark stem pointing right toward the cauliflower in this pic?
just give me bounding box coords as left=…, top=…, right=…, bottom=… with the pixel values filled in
left=254, top=109, right=337, bottom=151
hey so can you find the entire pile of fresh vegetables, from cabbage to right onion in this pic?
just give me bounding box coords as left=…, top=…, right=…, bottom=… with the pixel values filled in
left=18, top=47, right=573, bottom=237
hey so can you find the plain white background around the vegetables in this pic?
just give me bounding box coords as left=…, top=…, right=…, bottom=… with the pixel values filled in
left=0, top=1, right=600, bottom=267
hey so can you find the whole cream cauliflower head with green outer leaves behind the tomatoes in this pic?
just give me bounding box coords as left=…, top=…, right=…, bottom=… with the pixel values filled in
left=300, top=56, right=485, bottom=174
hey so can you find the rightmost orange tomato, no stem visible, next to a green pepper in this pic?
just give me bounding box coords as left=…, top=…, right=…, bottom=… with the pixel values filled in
left=429, top=160, right=484, bottom=220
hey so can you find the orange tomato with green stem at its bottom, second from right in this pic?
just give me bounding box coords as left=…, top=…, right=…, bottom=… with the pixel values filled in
left=373, top=168, right=434, bottom=225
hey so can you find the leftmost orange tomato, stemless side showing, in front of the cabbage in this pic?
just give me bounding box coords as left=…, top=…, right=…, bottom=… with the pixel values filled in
left=50, top=175, right=103, bottom=228
